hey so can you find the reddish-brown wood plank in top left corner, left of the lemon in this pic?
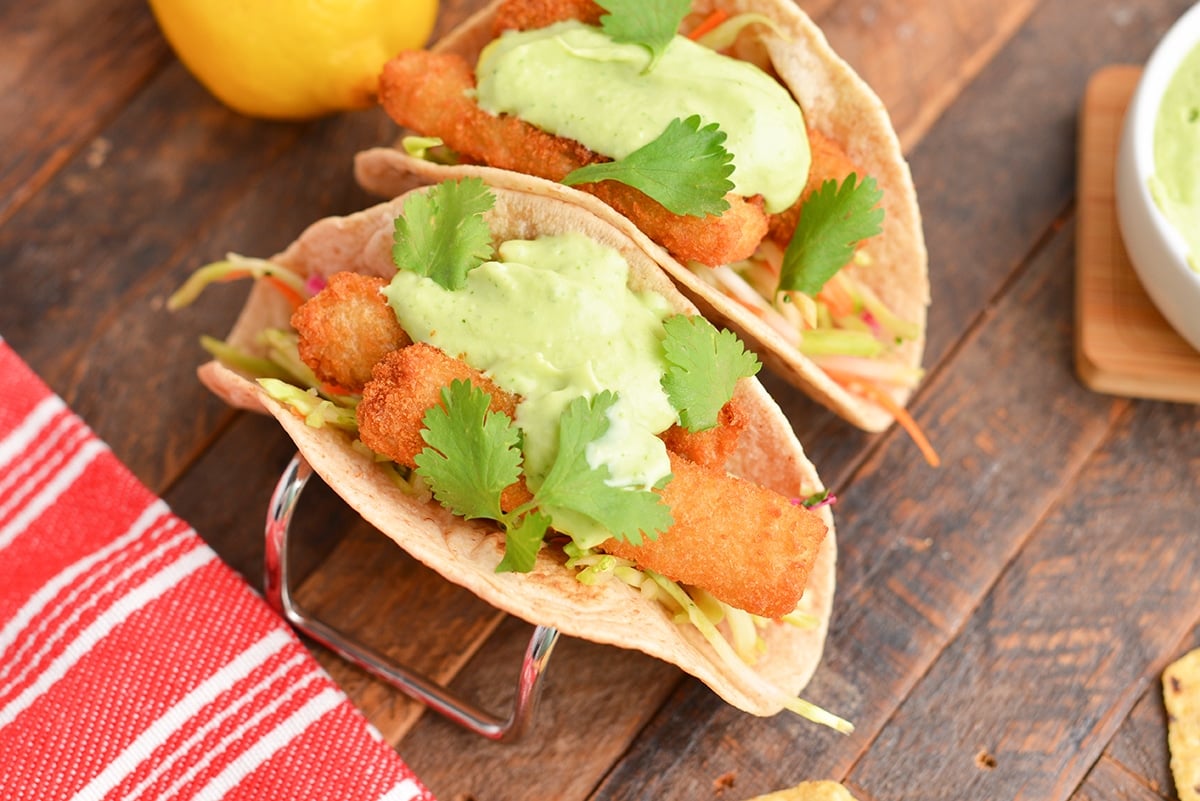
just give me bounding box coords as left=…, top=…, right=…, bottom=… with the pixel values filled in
left=0, top=0, right=170, bottom=224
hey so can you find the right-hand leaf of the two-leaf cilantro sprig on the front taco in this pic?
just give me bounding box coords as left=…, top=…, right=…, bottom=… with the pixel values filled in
left=536, top=390, right=673, bottom=546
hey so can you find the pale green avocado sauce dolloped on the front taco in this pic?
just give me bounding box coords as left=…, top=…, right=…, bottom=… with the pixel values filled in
left=384, top=234, right=677, bottom=489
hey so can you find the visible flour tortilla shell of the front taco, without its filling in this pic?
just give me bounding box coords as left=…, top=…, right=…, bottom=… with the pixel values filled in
left=199, top=187, right=836, bottom=715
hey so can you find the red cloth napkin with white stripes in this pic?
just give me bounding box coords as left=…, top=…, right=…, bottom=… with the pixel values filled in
left=0, top=339, right=433, bottom=801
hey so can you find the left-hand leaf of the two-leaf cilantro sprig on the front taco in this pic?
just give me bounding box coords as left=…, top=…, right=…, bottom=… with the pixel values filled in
left=416, top=380, right=521, bottom=520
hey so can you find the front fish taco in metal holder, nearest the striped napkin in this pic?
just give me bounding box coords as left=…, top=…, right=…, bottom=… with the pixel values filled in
left=172, top=179, right=846, bottom=728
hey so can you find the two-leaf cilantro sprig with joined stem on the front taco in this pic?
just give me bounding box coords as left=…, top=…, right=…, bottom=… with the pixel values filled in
left=416, top=380, right=672, bottom=573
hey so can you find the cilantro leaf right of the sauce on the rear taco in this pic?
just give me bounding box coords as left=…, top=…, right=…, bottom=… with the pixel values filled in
left=779, top=173, right=883, bottom=296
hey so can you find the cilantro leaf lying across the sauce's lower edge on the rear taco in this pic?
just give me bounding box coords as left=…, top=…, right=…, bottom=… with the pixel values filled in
left=563, top=114, right=733, bottom=217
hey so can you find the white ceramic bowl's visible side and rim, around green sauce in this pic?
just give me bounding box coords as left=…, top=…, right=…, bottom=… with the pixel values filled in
left=1116, top=4, right=1200, bottom=350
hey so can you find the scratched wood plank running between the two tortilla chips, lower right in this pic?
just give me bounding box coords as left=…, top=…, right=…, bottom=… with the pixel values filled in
left=852, top=371, right=1200, bottom=801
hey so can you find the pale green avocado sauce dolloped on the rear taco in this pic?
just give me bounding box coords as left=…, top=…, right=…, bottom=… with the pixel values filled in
left=475, top=20, right=811, bottom=213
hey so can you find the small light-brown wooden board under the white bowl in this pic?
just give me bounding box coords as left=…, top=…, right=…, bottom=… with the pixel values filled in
left=1075, top=65, right=1200, bottom=403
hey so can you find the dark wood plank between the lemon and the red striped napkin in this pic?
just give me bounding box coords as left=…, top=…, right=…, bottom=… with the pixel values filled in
left=0, top=67, right=301, bottom=492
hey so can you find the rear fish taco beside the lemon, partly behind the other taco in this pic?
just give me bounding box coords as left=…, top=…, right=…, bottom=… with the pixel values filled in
left=355, top=0, right=936, bottom=450
